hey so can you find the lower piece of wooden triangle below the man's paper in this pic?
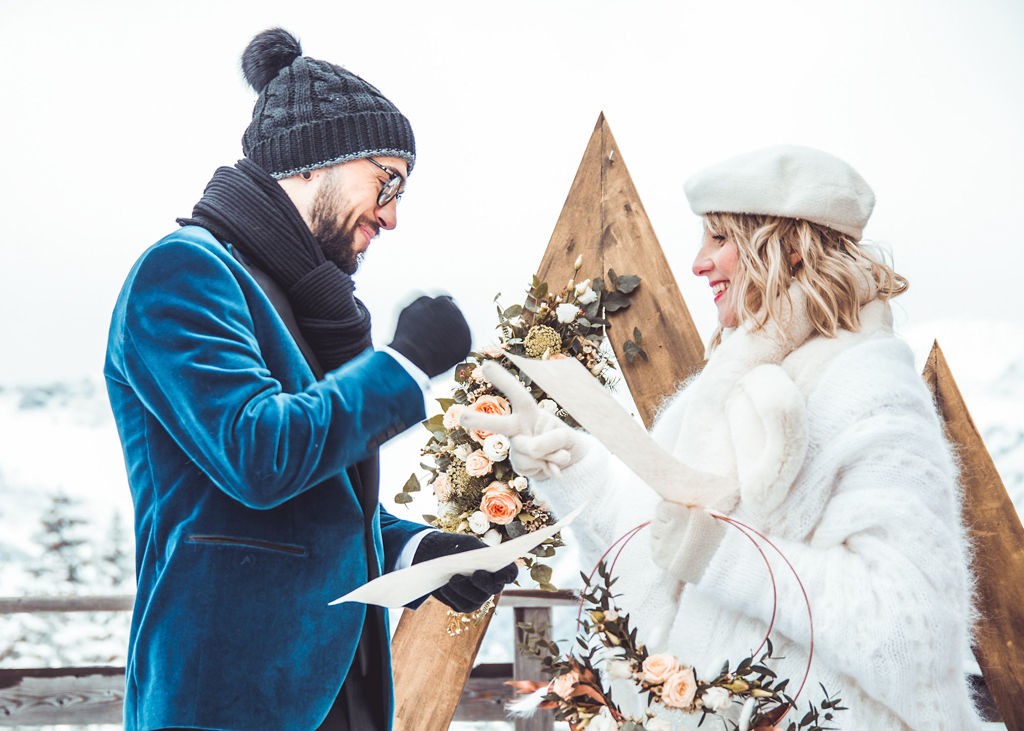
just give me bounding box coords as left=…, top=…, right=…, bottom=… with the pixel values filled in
left=391, top=598, right=495, bottom=731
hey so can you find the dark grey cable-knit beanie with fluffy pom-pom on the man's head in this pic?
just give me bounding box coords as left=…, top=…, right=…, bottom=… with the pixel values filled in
left=242, top=28, right=416, bottom=179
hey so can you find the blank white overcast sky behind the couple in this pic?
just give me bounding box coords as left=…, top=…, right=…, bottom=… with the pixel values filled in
left=0, top=0, right=1024, bottom=384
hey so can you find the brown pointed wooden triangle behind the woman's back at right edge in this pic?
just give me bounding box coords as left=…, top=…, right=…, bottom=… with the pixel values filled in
left=924, top=342, right=1024, bottom=731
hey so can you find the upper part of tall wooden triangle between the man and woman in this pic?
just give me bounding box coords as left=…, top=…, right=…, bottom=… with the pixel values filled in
left=537, top=114, right=705, bottom=427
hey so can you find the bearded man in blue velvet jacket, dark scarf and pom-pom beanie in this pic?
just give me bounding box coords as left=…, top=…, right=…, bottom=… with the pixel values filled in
left=104, top=29, right=516, bottom=731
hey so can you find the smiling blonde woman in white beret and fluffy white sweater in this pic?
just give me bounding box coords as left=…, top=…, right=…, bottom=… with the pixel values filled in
left=471, top=146, right=980, bottom=731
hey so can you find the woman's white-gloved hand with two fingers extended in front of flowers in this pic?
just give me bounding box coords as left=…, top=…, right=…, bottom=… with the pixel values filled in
left=459, top=360, right=588, bottom=477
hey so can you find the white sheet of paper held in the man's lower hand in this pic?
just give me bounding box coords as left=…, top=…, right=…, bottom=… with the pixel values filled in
left=328, top=507, right=583, bottom=607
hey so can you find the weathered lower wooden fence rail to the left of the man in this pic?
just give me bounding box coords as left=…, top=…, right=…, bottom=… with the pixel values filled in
left=0, top=668, right=125, bottom=726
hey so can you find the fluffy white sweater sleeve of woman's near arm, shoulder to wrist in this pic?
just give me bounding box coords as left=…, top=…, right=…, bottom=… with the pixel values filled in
left=692, top=338, right=972, bottom=728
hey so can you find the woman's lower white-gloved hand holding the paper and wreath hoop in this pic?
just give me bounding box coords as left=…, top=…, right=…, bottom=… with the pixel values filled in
left=650, top=501, right=725, bottom=584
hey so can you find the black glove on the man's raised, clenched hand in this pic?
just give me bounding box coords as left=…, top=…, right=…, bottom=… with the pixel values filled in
left=390, top=295, right=470, bottom=378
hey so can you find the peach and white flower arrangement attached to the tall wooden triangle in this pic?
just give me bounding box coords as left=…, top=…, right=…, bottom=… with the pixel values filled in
left=395, top=257, right=646, bottom=591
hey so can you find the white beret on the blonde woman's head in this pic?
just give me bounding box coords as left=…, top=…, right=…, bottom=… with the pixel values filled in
left=683, top=144, right=874, bottom=242
